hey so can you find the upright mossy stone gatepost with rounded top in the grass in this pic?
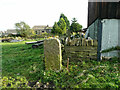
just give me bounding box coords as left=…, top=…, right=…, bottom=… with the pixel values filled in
left=44, top=38, right=62, bottom=71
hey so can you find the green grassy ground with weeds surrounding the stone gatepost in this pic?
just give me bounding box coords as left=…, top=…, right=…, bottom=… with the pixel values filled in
left=0, top=41, right=120, bottom=88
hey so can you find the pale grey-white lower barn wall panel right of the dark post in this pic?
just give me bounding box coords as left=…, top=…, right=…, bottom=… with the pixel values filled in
left=101, top=19, right=120, bottom=57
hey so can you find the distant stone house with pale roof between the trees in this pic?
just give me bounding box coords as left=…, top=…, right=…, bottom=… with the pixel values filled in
left=32, top=25, right=52, bottom=35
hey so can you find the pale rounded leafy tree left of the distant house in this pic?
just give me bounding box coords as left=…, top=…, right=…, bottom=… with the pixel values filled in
left=15, top=22, right=34, bottom=37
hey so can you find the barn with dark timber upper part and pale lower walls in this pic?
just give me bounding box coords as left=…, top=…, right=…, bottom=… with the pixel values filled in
left=87, top=0, right=120, bottom=60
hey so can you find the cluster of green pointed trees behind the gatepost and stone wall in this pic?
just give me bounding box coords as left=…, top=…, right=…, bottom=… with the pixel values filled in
left=51, top=14, right=82, bottom=36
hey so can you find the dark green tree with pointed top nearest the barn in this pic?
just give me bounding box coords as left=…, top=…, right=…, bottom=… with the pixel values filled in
left=70, top=18, right=82, bottom=32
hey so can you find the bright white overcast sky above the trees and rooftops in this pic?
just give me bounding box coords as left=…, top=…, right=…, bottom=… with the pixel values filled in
left=0, top=0, right=88, bottom=31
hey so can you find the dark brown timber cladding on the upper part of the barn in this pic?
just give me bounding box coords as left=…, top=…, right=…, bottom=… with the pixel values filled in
left=88, top=0, right=120, bottom=26
